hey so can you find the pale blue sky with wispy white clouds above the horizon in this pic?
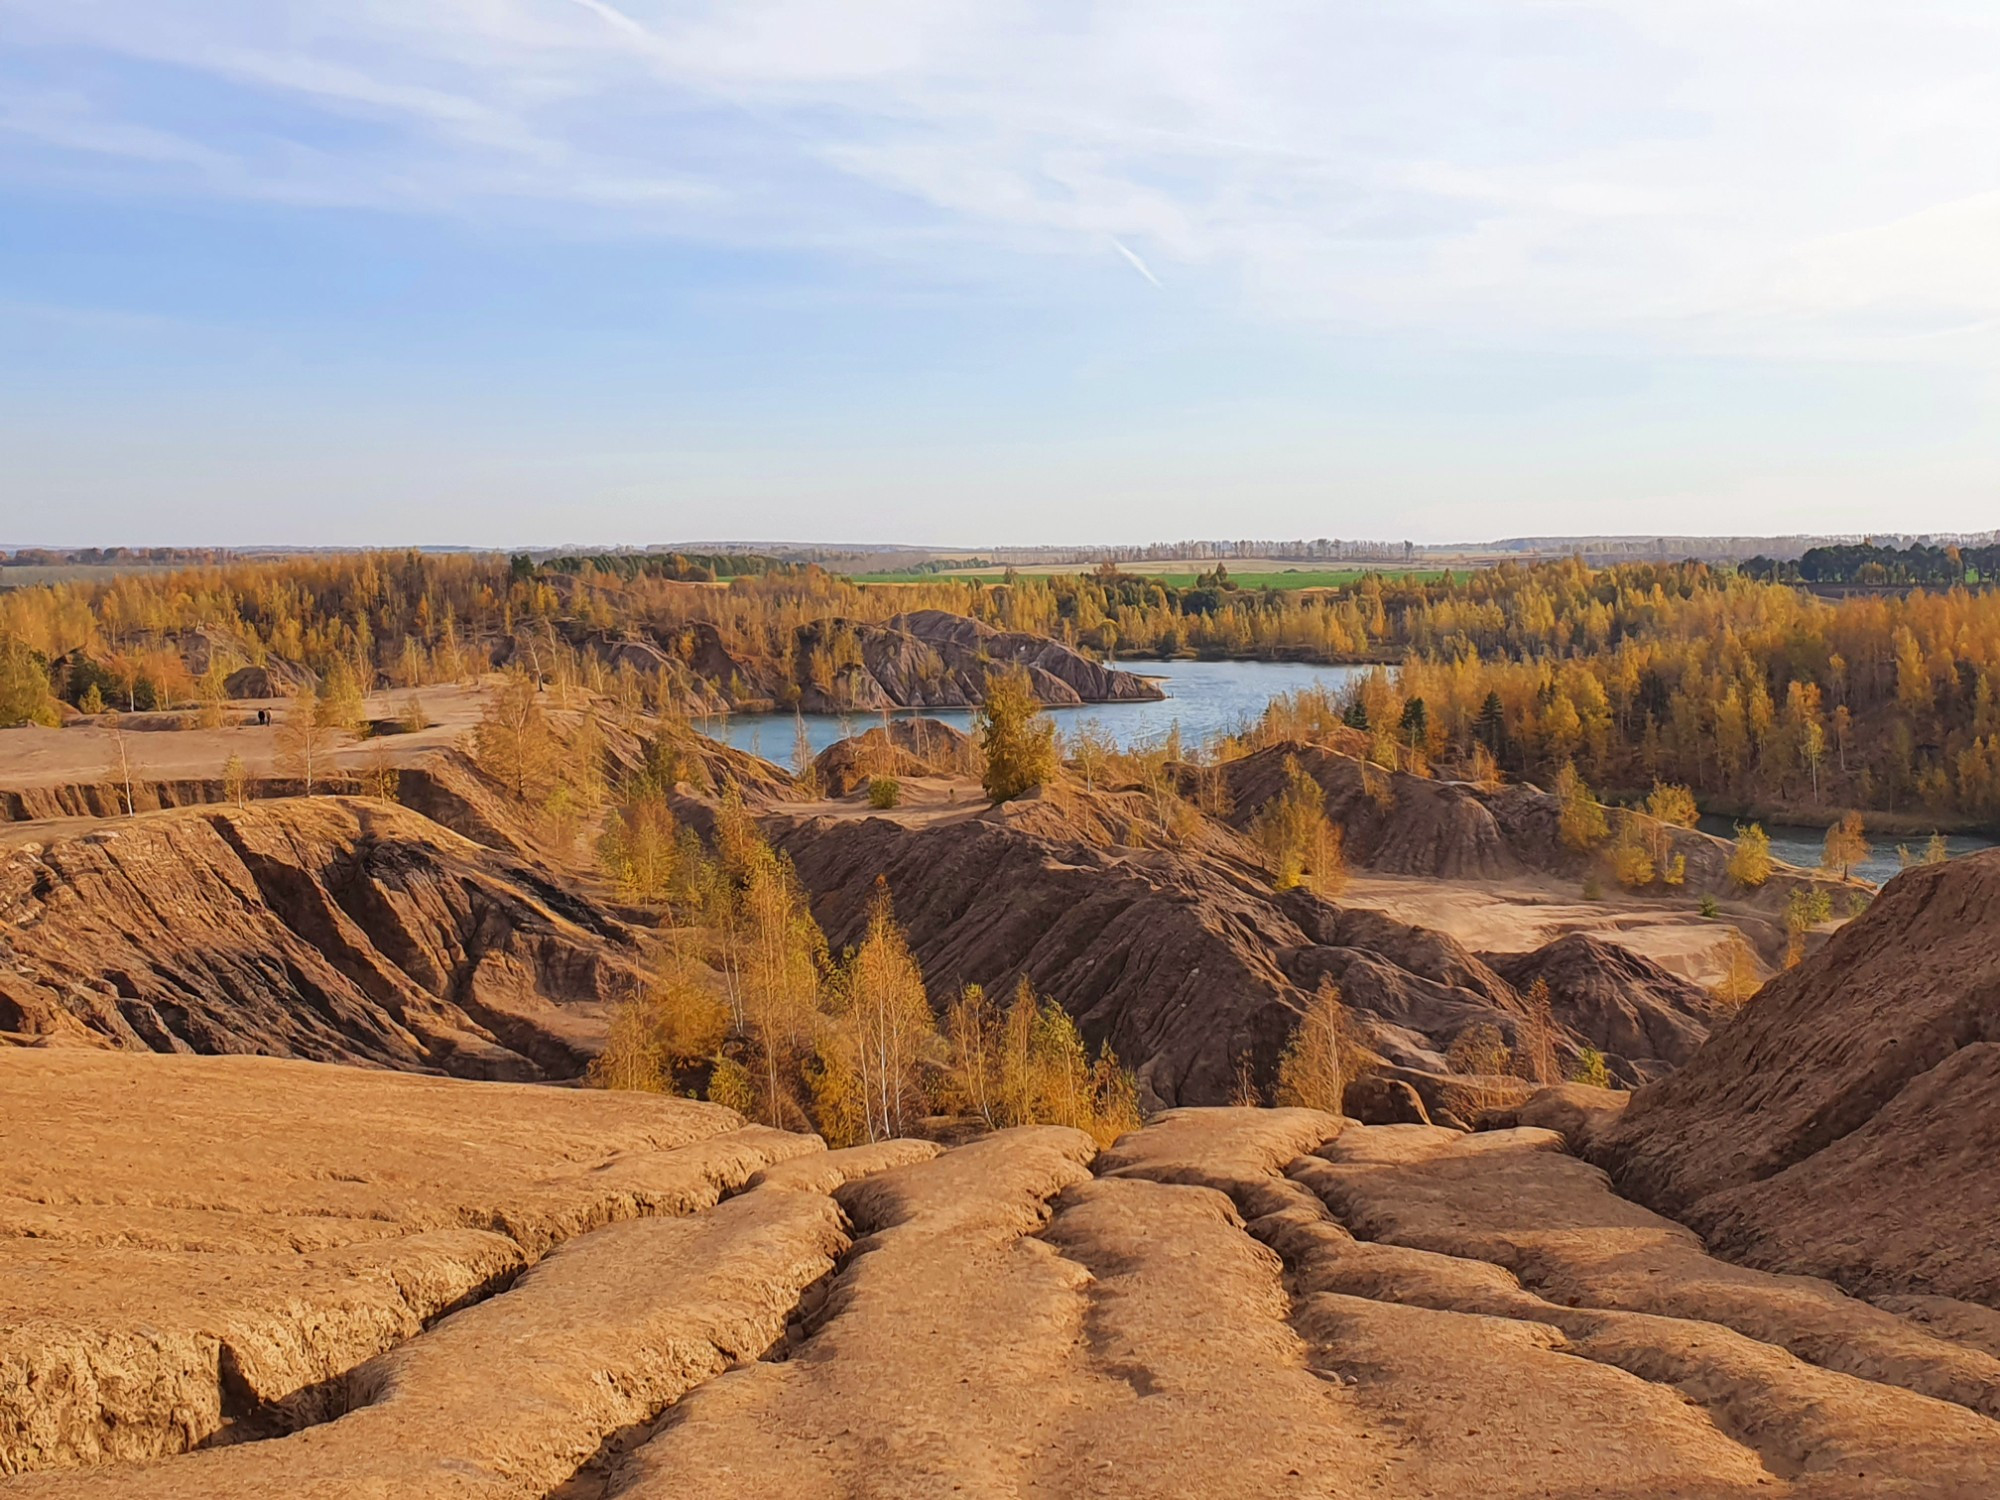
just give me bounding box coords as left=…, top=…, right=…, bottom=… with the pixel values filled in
left=0, top=0, right=2000, bottom=546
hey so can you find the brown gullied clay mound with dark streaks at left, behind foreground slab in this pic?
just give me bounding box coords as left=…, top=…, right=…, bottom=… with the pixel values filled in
left=0, top=798, right=644, bottom=1078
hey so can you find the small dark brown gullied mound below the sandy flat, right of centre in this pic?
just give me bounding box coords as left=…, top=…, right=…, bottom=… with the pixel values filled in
left=1486, top=932, right=1724, bottom=1084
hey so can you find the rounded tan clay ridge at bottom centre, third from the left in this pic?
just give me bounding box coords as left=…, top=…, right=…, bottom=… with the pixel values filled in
left=612, top=1128, right=1094, bottom=1500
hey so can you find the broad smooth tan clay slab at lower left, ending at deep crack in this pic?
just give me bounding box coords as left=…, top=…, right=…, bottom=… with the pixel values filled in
left=0, top=1048, right=824, bottom=1472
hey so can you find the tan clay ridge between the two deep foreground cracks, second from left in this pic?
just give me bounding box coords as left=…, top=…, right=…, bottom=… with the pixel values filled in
left=5, top=1146, right=930, bottom=1500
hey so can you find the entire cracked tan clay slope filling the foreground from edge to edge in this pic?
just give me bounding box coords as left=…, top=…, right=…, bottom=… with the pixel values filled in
left=0, top=1054, right=2000, bottom=1500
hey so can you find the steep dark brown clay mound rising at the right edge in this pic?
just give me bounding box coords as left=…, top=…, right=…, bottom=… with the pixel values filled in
left=1592, top=854, right=2000, bottom=1308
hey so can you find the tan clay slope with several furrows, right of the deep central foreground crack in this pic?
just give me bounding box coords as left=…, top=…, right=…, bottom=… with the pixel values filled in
left=610, top=1110, right=2000, bottom=1500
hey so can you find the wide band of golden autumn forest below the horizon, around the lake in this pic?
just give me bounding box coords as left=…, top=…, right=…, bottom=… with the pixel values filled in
left=11, top=552, right=2000, bottom=822
